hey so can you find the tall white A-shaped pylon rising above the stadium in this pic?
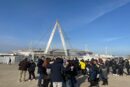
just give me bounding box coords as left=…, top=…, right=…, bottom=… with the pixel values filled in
left=44, top=21, right=68, bottom=56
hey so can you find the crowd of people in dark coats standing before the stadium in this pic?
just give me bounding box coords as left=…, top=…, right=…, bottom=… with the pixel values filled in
left=19, top=57, right=130, bottom=87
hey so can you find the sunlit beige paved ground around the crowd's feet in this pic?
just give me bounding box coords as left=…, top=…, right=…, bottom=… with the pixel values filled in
left=0, top=64, right=130, bottom=87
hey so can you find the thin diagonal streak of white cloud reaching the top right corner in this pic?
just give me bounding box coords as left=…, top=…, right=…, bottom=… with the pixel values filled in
left=66, top=0, right=130, bottom=31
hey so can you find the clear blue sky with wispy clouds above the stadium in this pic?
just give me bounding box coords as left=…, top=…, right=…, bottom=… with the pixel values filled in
left=0, top=0, right=130, bottom=55
